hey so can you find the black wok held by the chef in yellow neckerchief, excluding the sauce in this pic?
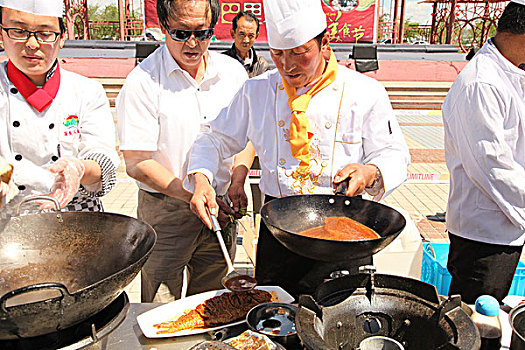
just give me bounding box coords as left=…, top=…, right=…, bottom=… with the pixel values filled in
left=261, top=194, right=406, bottom=262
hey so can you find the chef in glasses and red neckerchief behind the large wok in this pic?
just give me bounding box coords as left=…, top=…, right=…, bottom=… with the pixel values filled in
left=0, top=0, right=119, bottom=211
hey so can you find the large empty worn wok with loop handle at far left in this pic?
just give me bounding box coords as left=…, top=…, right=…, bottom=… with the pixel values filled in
left=0, top=200, right=156, bottom=340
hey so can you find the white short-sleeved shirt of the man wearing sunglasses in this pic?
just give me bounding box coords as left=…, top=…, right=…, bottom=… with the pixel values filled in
left=117, top=46, right=248, bottom=195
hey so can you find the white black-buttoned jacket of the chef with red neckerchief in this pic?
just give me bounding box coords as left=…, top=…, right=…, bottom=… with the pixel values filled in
left=0, top=62, right=120, bottom=206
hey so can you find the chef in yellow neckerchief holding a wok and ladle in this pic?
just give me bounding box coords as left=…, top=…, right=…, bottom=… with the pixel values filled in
left=185, top=0, right=410, bottom=295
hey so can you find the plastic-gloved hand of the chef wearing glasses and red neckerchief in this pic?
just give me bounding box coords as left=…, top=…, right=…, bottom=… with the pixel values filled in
left=40, top=157, right=86, bottom=209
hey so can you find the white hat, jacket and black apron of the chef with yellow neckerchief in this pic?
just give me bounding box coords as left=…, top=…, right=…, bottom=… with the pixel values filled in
left=185, top=0, right=410, bottom=295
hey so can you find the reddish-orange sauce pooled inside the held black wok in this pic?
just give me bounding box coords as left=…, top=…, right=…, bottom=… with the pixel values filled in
left=298, top=216, right=380, bottom=241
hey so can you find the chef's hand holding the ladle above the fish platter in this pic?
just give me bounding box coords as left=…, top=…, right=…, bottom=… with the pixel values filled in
left=190, top=173, right=219, bottom=230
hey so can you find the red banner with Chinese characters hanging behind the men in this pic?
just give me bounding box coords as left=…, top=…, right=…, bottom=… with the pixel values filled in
left=145, top=0, right=376, bottom=43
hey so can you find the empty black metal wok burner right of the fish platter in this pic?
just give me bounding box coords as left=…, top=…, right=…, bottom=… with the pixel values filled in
left=295, top=273, right=479, bottom=350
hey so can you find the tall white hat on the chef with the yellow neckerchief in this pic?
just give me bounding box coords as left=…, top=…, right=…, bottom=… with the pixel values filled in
left=263, top=0, right=326, bottom=50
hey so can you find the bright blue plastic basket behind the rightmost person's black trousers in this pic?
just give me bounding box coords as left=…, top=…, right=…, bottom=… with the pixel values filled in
left=421, top=243, right=525, bottom=296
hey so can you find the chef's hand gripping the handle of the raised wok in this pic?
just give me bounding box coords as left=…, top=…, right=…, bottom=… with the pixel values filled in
left=333, top=163, right=377, bottom=197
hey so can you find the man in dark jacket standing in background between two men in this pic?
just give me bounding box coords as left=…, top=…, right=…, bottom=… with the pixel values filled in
left=223, top=11, right=270, bottom=78
